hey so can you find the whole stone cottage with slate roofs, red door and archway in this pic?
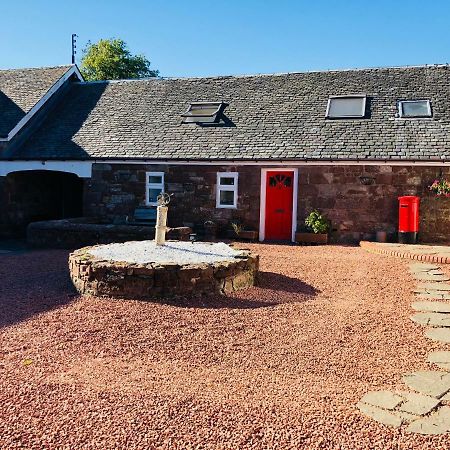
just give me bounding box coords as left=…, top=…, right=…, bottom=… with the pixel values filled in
left=0, top=65, right=450, bottom=242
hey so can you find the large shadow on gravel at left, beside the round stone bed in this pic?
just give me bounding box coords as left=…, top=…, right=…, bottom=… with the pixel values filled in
left=0, top=250, right=76, bottom=328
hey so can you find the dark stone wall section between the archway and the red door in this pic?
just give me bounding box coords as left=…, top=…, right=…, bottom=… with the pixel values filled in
left=85, top=164, right=260, bottom=233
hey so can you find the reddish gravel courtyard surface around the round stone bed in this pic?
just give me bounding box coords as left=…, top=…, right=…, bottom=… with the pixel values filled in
left=0, top=244, right=450, bottom=450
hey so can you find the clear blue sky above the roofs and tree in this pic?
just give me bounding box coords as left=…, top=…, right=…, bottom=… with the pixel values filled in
left=0, top=0, right=450, bottom=76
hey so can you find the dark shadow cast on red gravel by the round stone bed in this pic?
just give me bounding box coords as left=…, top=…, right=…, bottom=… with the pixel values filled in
left=160, top=272, right=320, bottom=309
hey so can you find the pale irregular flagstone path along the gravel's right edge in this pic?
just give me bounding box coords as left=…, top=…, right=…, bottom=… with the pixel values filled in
left=357, top=262, right=450, bottom=435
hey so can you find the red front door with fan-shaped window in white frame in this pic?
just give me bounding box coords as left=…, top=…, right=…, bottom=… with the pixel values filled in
left=265, top=170, right=294, bottom=240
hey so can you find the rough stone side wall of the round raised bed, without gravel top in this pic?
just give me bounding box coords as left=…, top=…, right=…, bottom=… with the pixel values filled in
left=69, top=241, right=259, bottom=300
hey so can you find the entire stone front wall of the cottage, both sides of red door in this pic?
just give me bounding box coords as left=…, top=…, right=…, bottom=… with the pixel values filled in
left=81, top=164, right=450, bottom=242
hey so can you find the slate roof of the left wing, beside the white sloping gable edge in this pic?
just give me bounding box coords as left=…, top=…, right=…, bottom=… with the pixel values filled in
left=0, top=66, right=71, bottom=137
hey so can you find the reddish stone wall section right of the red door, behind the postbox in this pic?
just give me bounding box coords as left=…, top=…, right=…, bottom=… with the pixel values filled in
left=298, top=165, right=450, bottom=242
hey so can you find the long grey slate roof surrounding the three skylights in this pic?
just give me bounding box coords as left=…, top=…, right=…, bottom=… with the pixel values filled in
left=9, top=65, right=450, bottom=160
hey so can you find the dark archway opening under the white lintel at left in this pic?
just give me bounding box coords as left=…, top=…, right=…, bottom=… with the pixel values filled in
left=7, top=170, right=83, bottom=234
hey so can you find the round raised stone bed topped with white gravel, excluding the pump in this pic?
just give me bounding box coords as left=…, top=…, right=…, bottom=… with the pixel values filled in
left=69, top=241, right=259, bottom=300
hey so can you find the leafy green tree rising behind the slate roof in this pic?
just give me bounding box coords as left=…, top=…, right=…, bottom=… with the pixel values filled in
left=80, top=39, right=159, bottom=81
